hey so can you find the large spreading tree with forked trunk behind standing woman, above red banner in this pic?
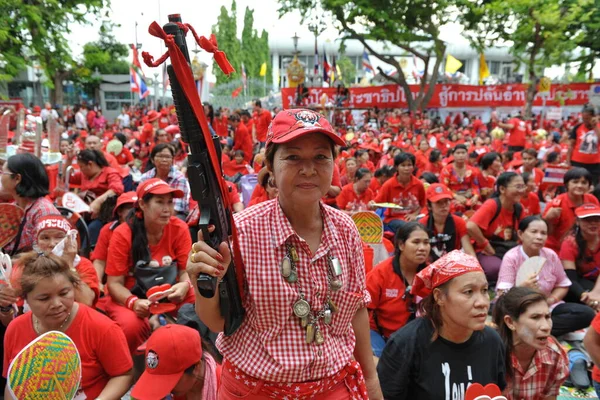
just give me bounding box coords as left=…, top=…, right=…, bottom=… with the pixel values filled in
left=279, top=0, right=470, bottom=110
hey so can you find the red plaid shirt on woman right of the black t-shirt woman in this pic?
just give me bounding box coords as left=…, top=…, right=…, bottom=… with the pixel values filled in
left=504, top=337, right=569, bottom=400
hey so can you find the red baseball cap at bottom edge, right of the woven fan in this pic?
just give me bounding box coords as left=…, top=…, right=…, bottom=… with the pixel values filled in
left=131, top=324, right=202, bottom=400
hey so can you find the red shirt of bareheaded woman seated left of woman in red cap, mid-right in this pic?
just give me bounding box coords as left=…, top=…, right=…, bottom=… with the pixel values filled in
left=375, top=175, right=425, bottom=224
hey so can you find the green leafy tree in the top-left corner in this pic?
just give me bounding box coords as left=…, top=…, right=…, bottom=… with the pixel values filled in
left=0, top=0, right=109, bottom=103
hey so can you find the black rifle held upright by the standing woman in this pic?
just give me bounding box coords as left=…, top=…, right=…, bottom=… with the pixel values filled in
left=163, top=14, right=245, bottom=335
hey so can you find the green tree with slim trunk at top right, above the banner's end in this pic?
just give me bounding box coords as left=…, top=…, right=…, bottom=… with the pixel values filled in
left=466, top=0, right=597, bottom=118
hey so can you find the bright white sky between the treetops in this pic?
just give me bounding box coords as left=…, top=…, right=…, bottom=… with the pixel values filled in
left=68, top=0, right=465, bottom=81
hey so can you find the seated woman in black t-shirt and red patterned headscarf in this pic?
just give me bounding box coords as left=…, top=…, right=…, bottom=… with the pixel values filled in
left=377, top=250, right=506, bottom=400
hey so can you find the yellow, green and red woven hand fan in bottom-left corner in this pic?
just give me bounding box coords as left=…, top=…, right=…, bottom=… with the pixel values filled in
left=7, top=331, right=81, bottom=400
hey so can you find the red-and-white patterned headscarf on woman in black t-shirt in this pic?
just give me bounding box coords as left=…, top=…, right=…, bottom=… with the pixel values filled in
left=411, top=250, right=483, bottom=297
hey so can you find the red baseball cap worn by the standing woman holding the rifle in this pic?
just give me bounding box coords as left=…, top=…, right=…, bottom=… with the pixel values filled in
left=266, top=109, right=346, bottom=147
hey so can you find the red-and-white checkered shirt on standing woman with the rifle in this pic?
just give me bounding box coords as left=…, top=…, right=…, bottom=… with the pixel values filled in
left=217, top=199, right=370, bottom=383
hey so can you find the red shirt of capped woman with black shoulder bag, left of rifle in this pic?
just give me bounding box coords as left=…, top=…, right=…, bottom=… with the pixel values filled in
left=106, top=217, right=194, bottom=302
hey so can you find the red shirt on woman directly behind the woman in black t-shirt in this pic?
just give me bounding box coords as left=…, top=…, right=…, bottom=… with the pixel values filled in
left=367, top=257, right=412, bottom=338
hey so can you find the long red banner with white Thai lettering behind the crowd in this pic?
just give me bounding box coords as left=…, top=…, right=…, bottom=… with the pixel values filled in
left=281, top=83, right=591, bottom=108
